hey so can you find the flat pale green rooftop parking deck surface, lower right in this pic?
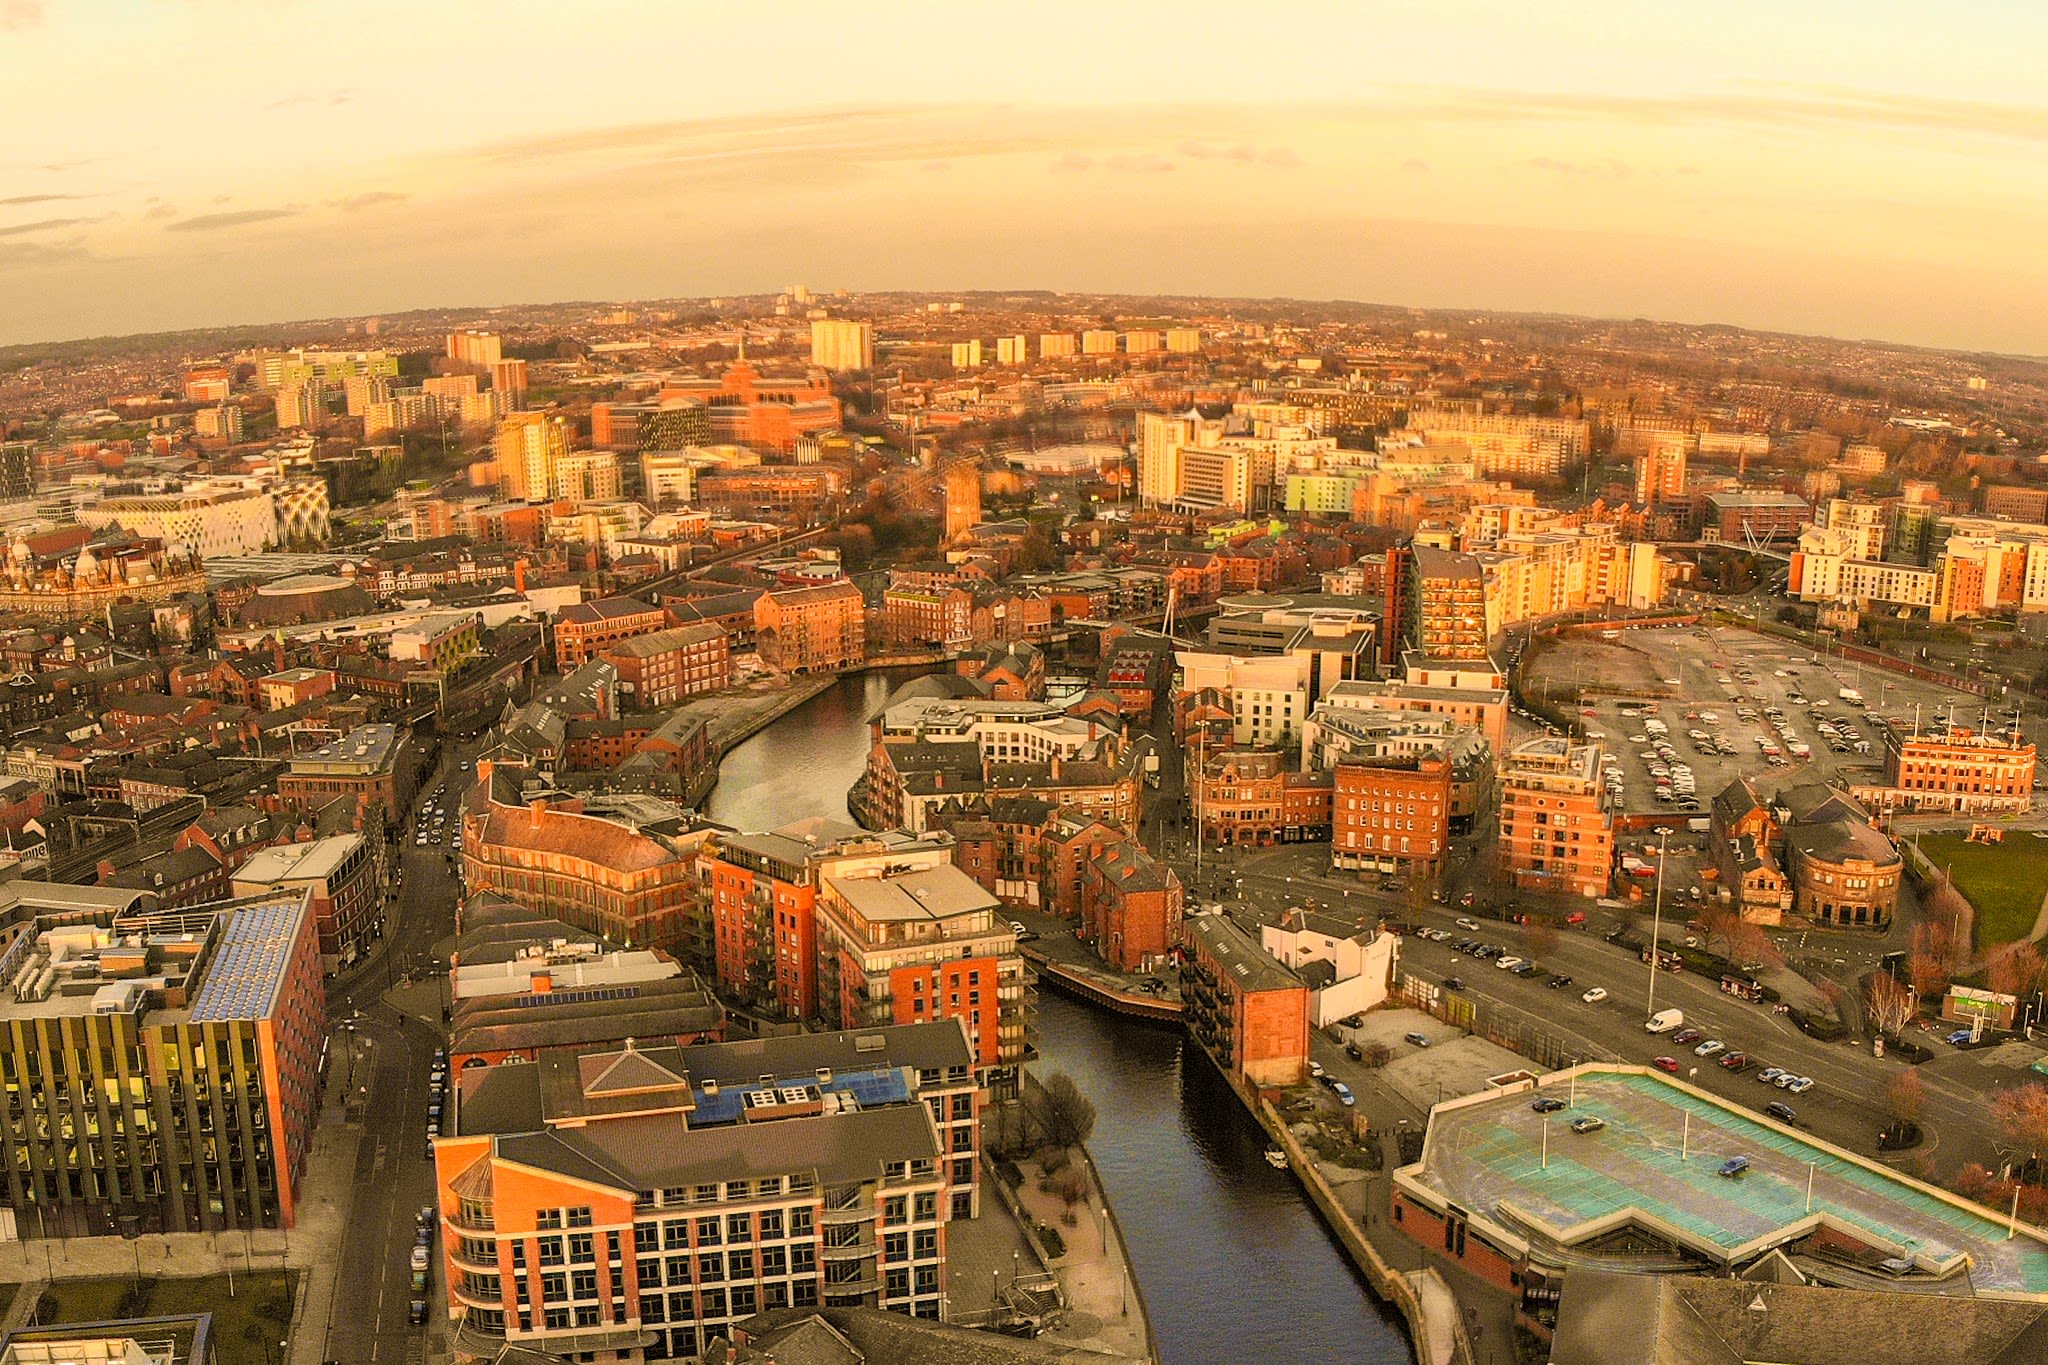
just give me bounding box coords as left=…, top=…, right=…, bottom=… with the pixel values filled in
left=1400, top=1064, right=2048, bottom=1300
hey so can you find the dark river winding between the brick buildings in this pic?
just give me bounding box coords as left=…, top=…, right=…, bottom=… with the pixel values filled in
left=711, top=675, right=1413, bottom=1365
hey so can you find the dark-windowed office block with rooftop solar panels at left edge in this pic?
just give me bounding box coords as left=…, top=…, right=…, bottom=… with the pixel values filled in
left=0, top=882, right=326, bottom=1238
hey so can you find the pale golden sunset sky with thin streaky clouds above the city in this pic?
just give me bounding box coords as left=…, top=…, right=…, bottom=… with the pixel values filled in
left=0, top=0, right=2048, bottom=354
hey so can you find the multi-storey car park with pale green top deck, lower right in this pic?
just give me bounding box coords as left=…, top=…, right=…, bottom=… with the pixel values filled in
left=1389, top=1064, right=2048, bottom=1302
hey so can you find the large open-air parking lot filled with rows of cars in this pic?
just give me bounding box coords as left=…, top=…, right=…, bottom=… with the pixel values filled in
left=1552, top=626, right=1985, bottom=817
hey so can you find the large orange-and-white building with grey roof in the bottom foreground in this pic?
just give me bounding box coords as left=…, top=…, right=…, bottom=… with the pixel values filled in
left=434, top=1025, right=962, bottom=1361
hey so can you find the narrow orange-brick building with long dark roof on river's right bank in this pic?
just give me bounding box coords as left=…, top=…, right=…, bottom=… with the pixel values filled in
left=1180, top=913, right=1309, bottom=1087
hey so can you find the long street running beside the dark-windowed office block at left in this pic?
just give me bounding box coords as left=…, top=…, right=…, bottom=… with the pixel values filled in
left=324, top=745, right=469, bottom=1365
